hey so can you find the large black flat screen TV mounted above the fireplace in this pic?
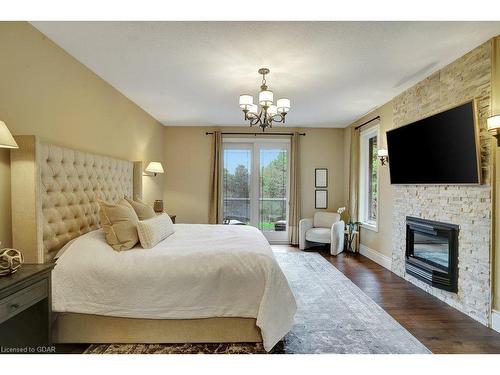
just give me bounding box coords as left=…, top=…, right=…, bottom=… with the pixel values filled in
left=387, top=101, right=481, bottom=185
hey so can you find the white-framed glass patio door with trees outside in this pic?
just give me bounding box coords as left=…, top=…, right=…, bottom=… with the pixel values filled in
left=222, top=138, right=290, bottom=243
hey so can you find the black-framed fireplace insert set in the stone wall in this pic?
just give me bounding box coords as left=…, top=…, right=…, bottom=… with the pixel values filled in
left=405, top=216, right=459, bottom=293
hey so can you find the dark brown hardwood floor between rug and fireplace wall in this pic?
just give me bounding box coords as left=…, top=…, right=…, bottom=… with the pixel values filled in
left=282, top=246, right=500, bottom=353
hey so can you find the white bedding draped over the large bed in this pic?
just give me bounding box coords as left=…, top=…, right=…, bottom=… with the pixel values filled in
left=52, top=224, right=297, bottom=351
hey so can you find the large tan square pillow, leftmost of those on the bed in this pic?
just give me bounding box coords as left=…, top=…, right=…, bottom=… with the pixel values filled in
left=97, top=199, right=139, bottom=251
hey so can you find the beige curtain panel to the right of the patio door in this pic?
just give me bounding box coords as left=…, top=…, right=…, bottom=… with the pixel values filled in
left=288, top=132, right=300, bottom=245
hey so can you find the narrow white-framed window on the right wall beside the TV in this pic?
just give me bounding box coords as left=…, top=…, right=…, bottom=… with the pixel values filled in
left=359, top=125, right=379, bottom=230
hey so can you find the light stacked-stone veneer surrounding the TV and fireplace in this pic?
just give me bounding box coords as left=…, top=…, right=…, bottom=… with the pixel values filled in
left=392, top=42, right=492, bottom=324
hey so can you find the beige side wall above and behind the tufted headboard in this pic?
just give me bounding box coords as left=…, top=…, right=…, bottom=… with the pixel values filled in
left=0, top=22, right=164, bottom=245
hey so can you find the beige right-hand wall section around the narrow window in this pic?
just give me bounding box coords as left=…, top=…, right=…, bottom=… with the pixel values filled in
left=344, top=101, right=393, bottom=258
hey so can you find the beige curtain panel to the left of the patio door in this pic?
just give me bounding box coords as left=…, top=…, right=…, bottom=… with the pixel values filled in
left=208, top=131, right=222, bottom=224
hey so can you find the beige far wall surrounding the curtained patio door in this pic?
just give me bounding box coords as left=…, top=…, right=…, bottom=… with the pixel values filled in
left=164, top=127, right=345, bottom=223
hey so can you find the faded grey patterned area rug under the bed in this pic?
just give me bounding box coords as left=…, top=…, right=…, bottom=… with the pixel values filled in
left=85, top=252, right=430, bottom=354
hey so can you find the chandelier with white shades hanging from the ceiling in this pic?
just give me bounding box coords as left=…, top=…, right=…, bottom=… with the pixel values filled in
left=240, top=68, right=290, bottom=131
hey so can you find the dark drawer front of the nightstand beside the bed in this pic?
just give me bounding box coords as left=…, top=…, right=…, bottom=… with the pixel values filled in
left=0, top=279, right=48, bottom=323
